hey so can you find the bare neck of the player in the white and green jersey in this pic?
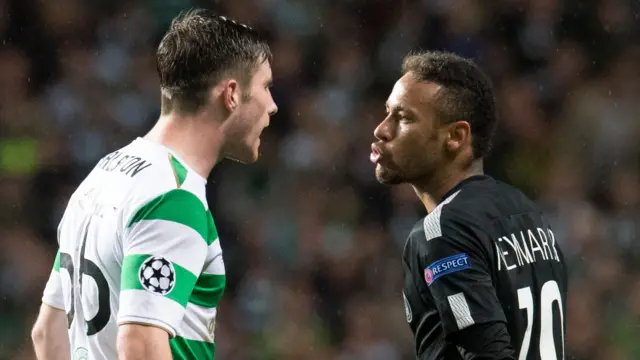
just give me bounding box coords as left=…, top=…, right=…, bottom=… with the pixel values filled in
left=144, top=114, right=222, bottom=179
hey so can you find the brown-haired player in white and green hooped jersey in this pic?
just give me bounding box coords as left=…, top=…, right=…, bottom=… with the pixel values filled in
left=32, top=10, right=277, bottom=360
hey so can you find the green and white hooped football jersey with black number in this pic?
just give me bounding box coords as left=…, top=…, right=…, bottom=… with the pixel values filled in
left=42, top=138, right=225, bottom=360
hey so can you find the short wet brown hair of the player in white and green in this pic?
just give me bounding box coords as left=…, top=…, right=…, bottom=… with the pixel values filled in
left=156, top=9, right=272, bottom=114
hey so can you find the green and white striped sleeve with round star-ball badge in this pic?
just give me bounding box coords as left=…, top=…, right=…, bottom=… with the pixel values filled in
left=118, top=189, right=213, bottom=337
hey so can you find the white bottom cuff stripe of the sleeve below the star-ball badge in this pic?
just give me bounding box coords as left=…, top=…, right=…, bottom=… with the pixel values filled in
left=118, top=290, right=185, bottom=336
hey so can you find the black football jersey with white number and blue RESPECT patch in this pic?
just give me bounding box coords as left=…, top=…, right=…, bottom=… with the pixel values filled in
left=403, top=175, right=567, bottom=360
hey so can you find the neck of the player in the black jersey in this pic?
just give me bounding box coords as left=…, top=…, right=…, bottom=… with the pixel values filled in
left=411, top=160, right=484, bottom=213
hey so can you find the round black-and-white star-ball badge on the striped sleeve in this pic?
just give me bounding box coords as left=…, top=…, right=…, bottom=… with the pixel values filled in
left=138, top=256, right=176, bottom=295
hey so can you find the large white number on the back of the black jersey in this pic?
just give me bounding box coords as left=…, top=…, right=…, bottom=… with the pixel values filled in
left=518, top=280, right=564, bottom=360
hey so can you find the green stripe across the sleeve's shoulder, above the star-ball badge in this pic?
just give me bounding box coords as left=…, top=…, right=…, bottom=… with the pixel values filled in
left=127, top=189, right=213, bottom=245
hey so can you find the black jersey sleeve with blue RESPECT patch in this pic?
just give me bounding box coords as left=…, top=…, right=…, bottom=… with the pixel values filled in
left=424, top=217, right=506, bottom=335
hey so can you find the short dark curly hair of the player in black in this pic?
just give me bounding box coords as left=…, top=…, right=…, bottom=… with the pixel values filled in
left=402, top=51, right=497, bottom=158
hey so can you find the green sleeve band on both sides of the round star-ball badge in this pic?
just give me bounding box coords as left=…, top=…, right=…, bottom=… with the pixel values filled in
left=120, top=254, right=197, bottom=307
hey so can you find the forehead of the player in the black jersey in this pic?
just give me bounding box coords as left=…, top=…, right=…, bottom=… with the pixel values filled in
left=386, top=73, right=440, bottom=112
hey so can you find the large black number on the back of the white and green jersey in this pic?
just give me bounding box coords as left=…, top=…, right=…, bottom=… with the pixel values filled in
left=60, top=219, right=111, bottom=335
